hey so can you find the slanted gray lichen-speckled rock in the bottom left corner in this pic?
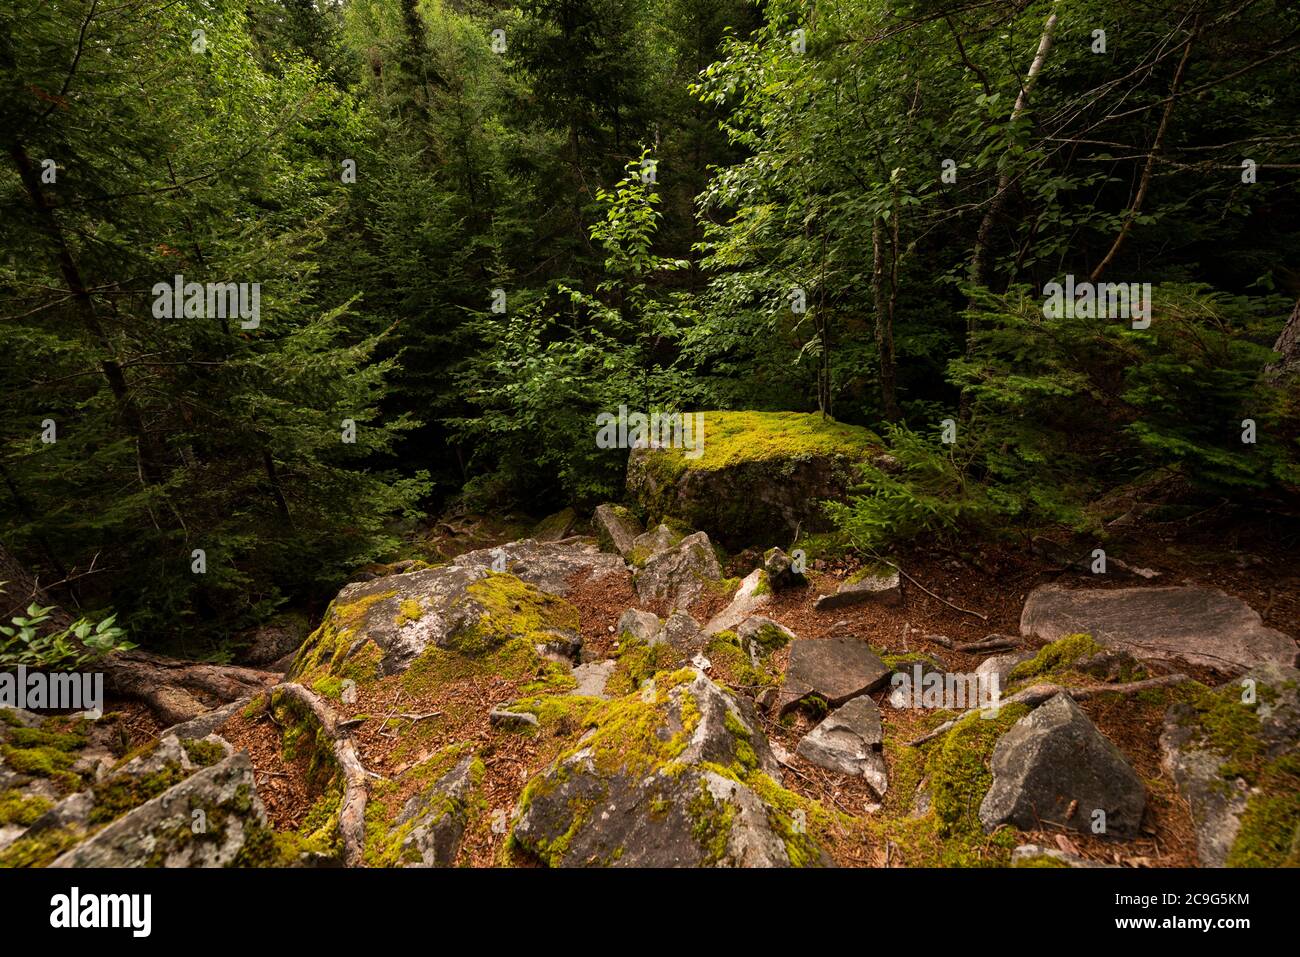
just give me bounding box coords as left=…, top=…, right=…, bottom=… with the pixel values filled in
left=51, top=752, right=267, bottom=867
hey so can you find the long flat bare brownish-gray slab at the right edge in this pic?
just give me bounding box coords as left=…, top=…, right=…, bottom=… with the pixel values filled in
left=1021, top=585, right=1296, bottom=672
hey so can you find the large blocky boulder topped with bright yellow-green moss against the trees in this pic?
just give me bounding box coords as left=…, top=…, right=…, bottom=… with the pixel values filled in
left=628, top=412, right=879, bottom=547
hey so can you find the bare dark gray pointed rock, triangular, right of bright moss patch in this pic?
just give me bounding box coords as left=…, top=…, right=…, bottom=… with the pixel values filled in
left=979, top=693, right=1147, bottom=837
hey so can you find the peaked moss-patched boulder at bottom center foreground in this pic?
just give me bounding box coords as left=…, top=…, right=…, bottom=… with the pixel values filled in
left=511, top=668, right=829, bottom=867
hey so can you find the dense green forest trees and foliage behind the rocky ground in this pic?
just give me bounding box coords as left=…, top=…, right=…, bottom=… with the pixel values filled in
left=0, top=0, right=1300, bottom=644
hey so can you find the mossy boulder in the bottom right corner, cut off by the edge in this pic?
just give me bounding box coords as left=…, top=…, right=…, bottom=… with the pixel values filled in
left=1160, top=666, right=1300, bottom=867
